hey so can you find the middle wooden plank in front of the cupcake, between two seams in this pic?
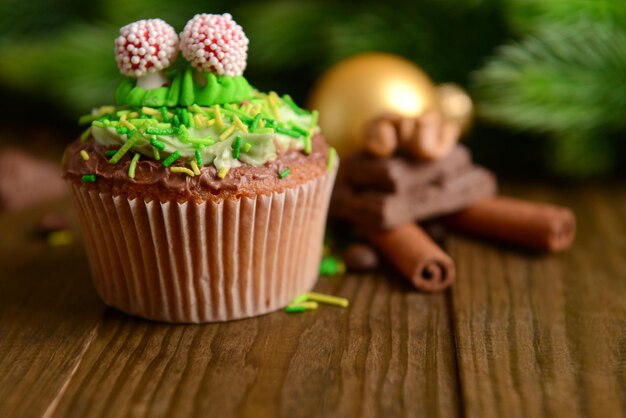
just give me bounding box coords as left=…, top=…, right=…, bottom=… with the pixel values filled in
left=52, top=276, right=459, bottom=417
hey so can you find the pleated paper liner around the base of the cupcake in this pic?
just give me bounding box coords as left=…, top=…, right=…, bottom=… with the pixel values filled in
left=72, top=172, right=335, bottom=323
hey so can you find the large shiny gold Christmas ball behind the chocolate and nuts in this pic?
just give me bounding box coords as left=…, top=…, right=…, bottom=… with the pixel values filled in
left=309, top=53, right=437, bottom=156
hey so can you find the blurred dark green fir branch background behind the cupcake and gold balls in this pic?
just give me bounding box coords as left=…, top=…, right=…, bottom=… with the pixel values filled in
left=0, top=0, right=626, bottom=179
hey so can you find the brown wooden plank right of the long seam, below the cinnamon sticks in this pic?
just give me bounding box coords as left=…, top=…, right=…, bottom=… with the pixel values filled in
left=450, top=186, right=626, bottom=418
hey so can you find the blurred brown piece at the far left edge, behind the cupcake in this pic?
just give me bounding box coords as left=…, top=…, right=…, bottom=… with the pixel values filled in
left=0, top=148, right=66, bottom=210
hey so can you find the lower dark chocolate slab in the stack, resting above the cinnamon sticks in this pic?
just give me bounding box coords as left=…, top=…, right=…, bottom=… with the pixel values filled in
left=331, top=167, right=496, bottom=229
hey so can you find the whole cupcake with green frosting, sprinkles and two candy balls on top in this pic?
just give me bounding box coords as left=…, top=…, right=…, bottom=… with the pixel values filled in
left=64, top=14, right=338, bottom=323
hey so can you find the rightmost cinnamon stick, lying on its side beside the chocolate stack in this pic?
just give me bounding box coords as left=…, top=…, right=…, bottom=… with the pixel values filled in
left=443, top=197, right=576, bottom=252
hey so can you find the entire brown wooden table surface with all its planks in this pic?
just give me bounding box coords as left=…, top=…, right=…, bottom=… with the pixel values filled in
left=0, top=184, right=626, bottom=418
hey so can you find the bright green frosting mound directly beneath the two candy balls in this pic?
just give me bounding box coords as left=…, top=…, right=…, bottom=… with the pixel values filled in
left=115, top=68, right=254, bottom=107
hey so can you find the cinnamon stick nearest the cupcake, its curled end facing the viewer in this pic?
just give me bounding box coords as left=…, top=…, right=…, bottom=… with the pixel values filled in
left=361, top=223, right=456, bottom=292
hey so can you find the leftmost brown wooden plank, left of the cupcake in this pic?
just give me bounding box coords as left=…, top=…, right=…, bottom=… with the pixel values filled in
left=0, top=202, right=104, bottom=417
